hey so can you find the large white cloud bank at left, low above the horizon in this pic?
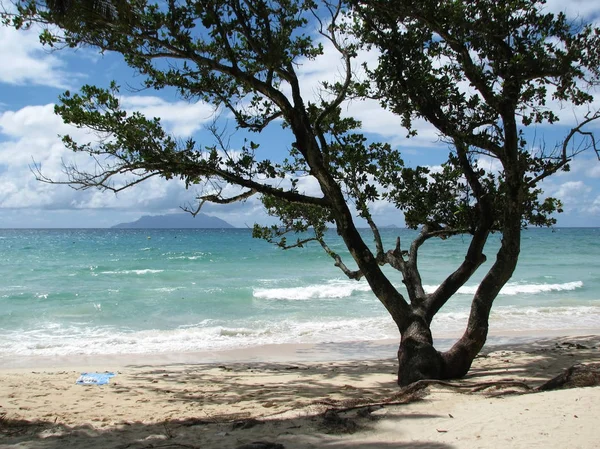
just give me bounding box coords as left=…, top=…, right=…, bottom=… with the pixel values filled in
left=0, top=102, right=206, bottom=211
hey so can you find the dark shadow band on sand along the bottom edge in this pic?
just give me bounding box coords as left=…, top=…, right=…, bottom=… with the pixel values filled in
left=0, top=408, right=454, bottom=449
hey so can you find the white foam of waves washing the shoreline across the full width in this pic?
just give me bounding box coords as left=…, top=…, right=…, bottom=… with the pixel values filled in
left=0, top=306, right=600, bottom=356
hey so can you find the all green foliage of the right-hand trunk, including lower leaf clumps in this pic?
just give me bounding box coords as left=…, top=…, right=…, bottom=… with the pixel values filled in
left=353, top=0, right=600, bottom=229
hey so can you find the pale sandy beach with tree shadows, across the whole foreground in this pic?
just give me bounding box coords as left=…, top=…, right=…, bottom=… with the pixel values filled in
left=0, top=336, right=600, bottom=449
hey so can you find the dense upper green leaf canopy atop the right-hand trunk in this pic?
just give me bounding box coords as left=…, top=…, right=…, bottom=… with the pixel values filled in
left=357, top=0, right=600, bottom=133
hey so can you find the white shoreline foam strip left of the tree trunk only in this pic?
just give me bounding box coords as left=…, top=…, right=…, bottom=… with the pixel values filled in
left=0, top=318, right=396, bottom=356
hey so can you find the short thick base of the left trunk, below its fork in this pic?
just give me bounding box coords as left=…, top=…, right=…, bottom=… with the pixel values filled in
left=398, top=317, right=446, bottom=387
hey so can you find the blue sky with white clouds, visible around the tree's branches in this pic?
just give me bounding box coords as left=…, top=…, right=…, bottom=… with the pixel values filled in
left=0, top=0, right=600, bottom=228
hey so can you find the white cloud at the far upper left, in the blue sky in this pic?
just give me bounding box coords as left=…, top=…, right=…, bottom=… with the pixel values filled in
left=0, top=26, right=82, bottom=89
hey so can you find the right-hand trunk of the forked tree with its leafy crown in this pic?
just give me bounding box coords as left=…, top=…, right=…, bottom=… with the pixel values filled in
left=356, top=0, right=600, bottom=378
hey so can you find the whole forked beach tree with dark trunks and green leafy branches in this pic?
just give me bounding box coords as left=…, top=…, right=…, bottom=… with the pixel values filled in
left=4, top=0, right=600, bottom=385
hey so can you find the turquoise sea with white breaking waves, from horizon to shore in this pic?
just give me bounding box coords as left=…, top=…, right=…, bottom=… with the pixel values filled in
left=0, top=228, right=600, bottom=356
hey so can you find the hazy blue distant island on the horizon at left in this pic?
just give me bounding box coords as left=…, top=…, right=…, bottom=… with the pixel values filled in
left=111, top=213, right=234, bottom=229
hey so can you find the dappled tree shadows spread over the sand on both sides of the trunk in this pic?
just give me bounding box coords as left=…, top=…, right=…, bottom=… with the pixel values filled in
left=0, top=337, right=600, bottom=449
